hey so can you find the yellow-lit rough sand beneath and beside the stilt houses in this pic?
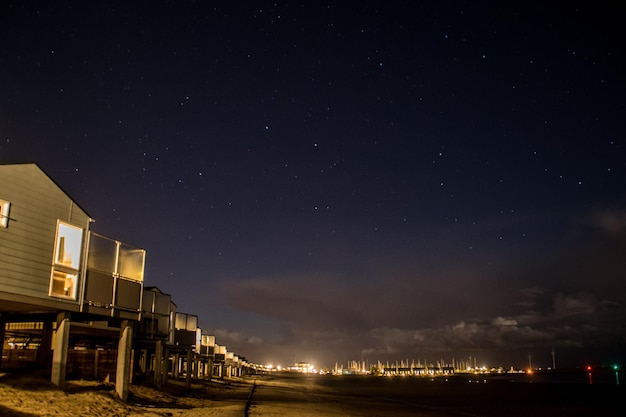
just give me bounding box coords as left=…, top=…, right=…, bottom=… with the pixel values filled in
left=0, top=371, right=253, bottom=417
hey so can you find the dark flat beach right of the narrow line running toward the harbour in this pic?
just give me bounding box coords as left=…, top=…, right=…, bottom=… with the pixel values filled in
left=249, top=375, right=626, bottom=417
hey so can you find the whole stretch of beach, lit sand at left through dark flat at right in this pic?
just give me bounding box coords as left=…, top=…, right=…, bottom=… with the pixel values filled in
left=0, top=371, right=626, bottom=417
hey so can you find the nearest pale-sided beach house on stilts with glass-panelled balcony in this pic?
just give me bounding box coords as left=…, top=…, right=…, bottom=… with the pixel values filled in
left=0, top=163, right=146, bottom=398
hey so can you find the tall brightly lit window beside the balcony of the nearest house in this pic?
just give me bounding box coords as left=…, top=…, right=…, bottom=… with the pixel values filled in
left=50, top=221, right=83, bottom=299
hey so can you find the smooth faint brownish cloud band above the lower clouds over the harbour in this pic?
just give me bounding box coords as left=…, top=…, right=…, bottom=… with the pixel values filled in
left=216, top=265, right=506, bottom=332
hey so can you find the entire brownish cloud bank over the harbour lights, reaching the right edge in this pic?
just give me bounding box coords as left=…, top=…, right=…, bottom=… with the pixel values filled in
left=208, top=206, right=626, bottom=365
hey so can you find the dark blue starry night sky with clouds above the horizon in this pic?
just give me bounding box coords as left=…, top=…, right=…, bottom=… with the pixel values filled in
left=0, top=0, right=626, bottom=368
